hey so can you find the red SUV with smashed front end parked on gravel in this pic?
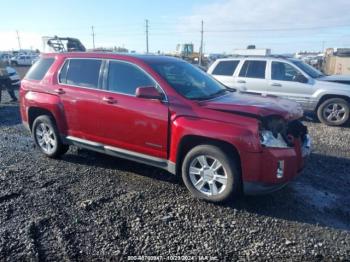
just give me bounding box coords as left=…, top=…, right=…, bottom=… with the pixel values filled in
left=20, top=53, right=310, bottom=202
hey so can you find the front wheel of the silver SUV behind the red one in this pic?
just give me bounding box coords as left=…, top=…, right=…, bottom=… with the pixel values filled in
left=317, top=98, right=350, bottom=126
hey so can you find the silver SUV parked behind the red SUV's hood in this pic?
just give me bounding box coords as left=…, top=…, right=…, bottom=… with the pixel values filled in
left=208, top=56, right=350, bottom=126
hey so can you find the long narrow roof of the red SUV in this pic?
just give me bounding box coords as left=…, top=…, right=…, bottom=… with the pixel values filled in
left=42, top=52, right=183, bottom=63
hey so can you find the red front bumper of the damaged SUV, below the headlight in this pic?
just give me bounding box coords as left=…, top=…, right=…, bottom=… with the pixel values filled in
left=242, top=135, right=311, bottom=195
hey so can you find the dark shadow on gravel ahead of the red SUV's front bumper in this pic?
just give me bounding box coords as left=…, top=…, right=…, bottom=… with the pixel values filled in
left=224, top=154, right=350, bottom=230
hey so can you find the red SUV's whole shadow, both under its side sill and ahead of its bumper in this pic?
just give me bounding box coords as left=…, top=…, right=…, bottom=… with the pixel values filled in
left=62, top=149, right=350, bottom=230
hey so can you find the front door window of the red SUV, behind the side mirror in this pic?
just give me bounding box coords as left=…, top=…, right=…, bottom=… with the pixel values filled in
left=107, top=61, right=156, bottom=95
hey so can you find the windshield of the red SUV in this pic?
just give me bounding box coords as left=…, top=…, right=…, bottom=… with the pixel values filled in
left=149, top=61, right=230, bottom=100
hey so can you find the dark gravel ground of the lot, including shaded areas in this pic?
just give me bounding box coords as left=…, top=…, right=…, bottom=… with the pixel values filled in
left=0, top=91, right=350, bottom=261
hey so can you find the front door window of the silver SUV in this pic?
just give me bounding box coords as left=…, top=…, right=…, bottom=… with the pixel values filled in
left=271, top=62, right=301, bottom=82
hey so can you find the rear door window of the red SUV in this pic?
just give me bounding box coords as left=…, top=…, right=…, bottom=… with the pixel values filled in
left=66, top=59, right=102, bottom=88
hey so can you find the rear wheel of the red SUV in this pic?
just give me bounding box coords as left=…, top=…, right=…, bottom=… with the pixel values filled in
left=32, top=115, right=69, bottom=158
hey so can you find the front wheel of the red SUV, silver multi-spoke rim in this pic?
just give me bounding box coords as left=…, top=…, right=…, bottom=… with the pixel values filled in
left=182, top=145, right=240, bottom=202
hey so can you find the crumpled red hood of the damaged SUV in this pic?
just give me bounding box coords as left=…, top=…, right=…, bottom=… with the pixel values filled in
left=200, top=92, right=303, bottom=120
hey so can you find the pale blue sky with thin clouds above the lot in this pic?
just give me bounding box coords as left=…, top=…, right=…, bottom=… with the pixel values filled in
left=0, top=0, right=350, bottom=53
